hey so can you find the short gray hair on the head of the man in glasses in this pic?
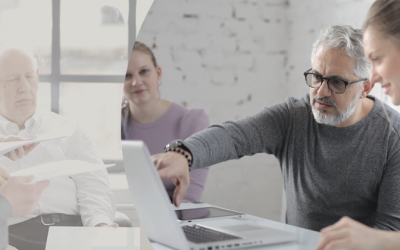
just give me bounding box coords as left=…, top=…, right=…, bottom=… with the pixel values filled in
left=311, top=25, right=371, bottom=78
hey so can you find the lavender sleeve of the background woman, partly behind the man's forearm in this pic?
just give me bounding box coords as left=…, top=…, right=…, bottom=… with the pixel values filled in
left=180, top=109, right=210, bottom=202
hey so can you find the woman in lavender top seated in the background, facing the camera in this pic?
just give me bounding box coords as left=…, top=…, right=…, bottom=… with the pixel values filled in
left=121, top=42, right=209, bottom=202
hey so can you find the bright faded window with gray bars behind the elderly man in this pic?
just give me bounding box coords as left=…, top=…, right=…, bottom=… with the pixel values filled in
left=0, top=0, right=136, bottom=168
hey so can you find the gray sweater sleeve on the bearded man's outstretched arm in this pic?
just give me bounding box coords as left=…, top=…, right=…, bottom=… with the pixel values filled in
left=183, top=98, right=294, bottom=169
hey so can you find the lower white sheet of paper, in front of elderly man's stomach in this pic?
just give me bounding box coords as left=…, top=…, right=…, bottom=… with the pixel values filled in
left=10, top=160, right=115, bottom=183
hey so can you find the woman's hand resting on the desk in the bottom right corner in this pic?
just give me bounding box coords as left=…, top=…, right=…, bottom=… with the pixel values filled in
left=316, top=217, right=400, bottom=250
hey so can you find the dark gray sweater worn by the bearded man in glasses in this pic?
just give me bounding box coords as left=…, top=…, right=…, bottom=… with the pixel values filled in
left=184, top=94, right=400, bottom=231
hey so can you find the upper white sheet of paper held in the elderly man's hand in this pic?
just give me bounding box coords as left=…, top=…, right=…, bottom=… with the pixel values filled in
left=0, top=123, right=75, bottom=155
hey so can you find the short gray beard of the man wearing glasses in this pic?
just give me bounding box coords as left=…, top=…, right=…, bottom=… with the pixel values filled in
left=312, top=88, right=362, bottom=126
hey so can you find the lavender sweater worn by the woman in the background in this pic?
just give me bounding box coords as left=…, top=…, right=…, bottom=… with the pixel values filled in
left=121, top=103, right=209, bottom=202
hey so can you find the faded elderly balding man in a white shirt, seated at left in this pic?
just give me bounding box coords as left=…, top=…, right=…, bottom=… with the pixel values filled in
left=0, top=48, right=118, bottom=250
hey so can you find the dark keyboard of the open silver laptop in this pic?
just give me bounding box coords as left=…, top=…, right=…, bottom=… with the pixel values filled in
left=182, top=225, right=241, bottom=243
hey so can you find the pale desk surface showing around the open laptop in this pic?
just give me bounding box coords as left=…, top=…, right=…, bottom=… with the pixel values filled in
left=152, top=204, right=320, bottom=250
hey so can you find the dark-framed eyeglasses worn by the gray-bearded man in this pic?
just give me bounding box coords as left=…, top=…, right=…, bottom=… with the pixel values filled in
left=304, top=69, right=368, bottom=94
